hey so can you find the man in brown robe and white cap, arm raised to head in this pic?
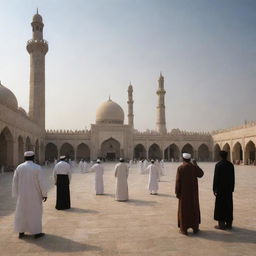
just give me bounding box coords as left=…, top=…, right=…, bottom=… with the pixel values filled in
left=175, top=153, right=204, bottom=235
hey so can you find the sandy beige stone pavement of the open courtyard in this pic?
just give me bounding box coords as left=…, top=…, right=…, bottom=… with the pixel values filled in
left=0, top=163, right=256, bottom=256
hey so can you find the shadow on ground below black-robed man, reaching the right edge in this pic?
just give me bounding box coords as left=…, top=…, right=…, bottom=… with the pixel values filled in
left=198, top=227, right=256, bottom=244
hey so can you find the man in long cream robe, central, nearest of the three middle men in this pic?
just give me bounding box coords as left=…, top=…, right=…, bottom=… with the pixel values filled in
left=115, top=158, right=129, bottom=201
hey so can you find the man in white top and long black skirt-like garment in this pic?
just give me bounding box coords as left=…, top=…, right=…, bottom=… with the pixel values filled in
left=53, top=156, right=72, bottom=210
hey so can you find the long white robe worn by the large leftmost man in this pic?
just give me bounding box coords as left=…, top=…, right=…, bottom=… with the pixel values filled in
left=12, top=161, right=47, bottom=234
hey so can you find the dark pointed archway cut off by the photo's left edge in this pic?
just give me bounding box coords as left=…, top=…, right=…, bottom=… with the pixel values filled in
left=0, top=127, right=14, bottom=170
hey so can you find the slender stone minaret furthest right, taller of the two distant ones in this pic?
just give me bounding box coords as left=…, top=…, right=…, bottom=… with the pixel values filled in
left=156, top=73, right=167, bottom=134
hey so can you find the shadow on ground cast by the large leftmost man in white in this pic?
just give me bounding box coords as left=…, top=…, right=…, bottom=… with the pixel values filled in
left=24, top=234, right=101, bottom=253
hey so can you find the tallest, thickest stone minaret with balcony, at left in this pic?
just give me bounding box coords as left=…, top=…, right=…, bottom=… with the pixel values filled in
left=27, top=10, right=48, bottom=129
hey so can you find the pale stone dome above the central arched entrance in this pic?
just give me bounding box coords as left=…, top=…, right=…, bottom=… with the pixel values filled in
left=96, top=99, right=124, bottom=124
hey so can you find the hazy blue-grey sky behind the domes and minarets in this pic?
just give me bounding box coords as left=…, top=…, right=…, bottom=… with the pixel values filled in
left=0, top=0, right=256, bottom=131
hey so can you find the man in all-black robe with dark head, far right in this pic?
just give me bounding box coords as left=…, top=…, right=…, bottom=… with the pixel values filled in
left=213, top=151, right=235, bottom=230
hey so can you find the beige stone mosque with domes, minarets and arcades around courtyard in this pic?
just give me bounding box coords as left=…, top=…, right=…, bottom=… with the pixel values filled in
left=0, top=13, right=256, bottom=171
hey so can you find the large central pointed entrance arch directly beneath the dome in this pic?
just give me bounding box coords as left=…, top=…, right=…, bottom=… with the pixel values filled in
left=101, top=138, right=121, bottom=161
